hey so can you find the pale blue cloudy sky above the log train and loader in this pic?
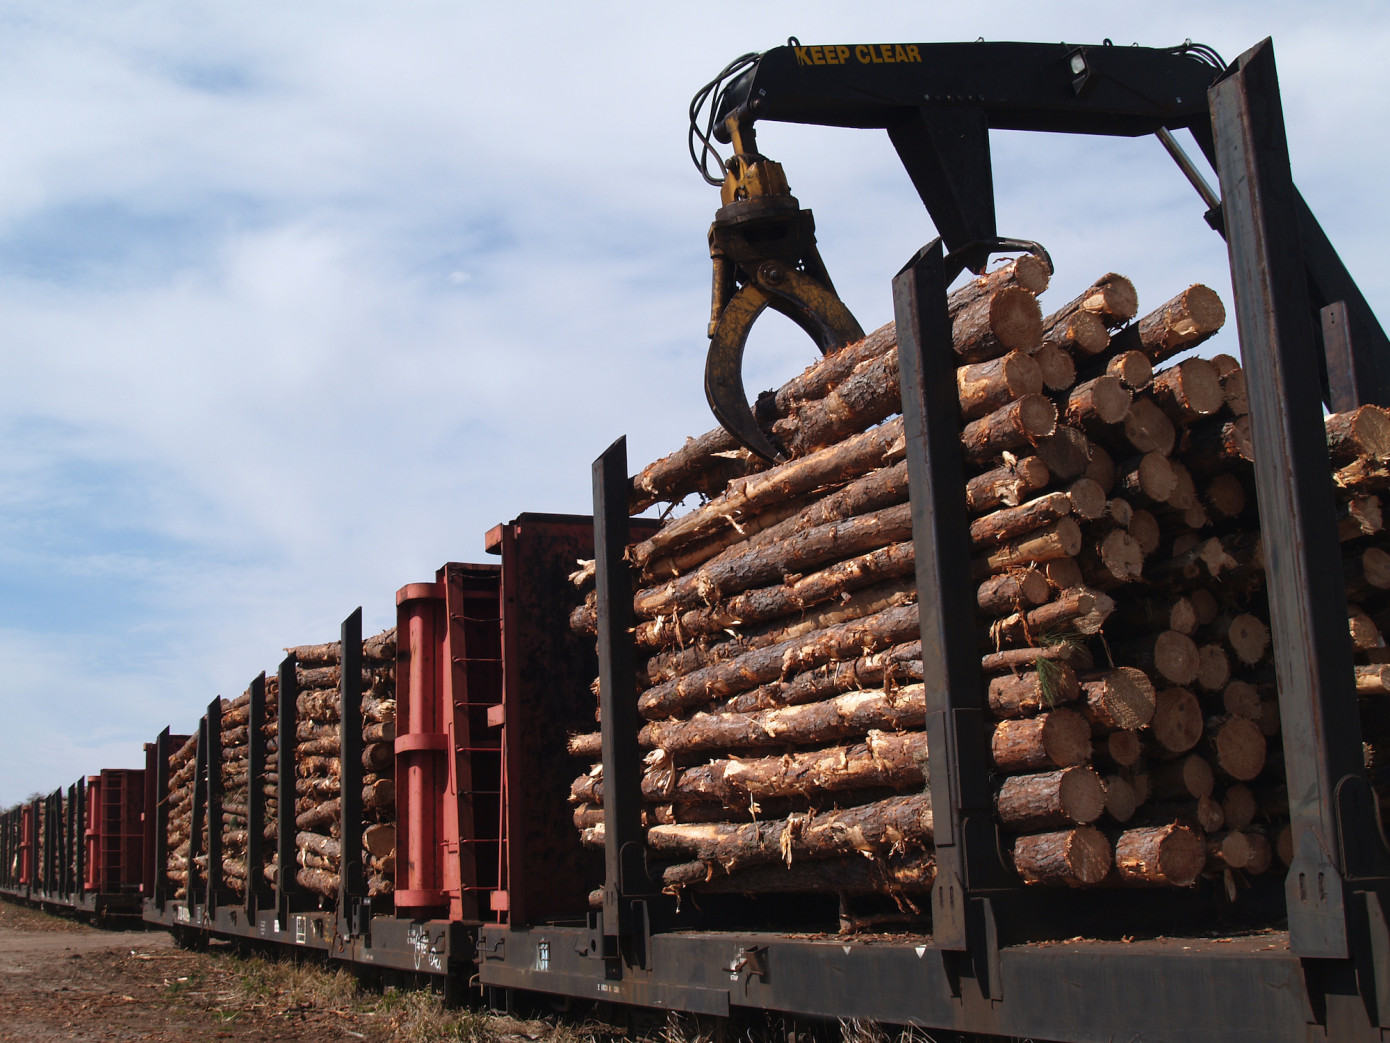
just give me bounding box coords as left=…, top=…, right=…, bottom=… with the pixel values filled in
left=0, top=0, right=1390, bottom=807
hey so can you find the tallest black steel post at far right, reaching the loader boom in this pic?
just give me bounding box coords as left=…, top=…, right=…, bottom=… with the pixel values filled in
left=1211, top=40, right=1379, bottom=958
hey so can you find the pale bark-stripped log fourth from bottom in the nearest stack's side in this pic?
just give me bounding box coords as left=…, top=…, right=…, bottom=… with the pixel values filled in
left=638, top=684, right=927, bottom=754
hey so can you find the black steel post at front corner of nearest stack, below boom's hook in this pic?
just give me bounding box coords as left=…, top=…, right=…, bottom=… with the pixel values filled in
left=892, top=239, right=1016, bottom=950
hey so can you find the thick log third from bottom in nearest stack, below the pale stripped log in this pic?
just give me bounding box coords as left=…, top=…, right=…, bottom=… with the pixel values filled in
left=642, top=731, right=927, bottom=808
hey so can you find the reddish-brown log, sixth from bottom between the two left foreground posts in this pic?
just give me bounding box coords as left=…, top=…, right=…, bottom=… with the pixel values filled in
left=638, top=605, right=917, bottom=720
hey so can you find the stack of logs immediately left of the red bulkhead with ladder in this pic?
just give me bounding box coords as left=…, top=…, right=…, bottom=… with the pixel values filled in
left=286, top=627, right=396, bottom=900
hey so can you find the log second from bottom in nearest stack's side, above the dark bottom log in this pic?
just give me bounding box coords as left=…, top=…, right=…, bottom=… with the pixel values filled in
left=646, top=793, right=931, bottom=872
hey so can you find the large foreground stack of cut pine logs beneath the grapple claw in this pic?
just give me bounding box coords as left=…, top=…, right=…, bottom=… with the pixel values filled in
left=571, top=256, right=1390, bottom=901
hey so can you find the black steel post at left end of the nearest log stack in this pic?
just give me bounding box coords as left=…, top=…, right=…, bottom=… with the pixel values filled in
left=594, top=437, right=651, bottom=937
